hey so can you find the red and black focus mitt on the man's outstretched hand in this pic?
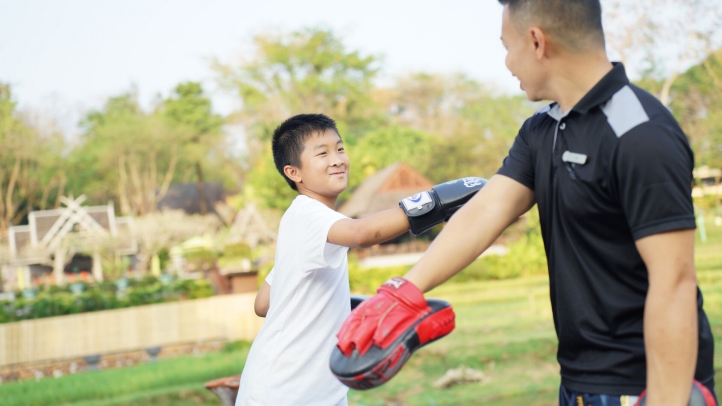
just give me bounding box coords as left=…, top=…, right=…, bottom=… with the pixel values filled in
left=331, top=278, right=454, bottom=389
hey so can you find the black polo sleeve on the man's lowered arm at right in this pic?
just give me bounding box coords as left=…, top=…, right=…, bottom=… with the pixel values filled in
left=611, top=123, right=696, bottom=240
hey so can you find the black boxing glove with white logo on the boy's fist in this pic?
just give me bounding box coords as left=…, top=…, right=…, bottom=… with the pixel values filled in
left=399, top=177, right=486, bottom=235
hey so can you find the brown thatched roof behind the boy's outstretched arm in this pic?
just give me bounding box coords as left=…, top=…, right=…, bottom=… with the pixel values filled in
left=338, top=162, right=434, bottom=218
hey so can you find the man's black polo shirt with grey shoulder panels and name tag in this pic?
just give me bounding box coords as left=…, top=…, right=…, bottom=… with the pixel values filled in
left=499, top=64, right=714, bottom=395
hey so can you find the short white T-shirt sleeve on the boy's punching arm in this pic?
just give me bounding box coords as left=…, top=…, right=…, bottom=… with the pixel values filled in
left=296, top=199, right=348, bottom=271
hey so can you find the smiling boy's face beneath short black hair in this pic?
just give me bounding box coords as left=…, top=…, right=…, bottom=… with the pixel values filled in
left=299, top=130, right=351, bottom=197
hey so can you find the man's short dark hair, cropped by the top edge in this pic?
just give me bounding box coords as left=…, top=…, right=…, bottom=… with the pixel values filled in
left=499, top=0, right=604, bottom=52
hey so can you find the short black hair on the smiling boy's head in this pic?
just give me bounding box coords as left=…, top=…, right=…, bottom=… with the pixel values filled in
left=271, top=114, right=340, bottom=191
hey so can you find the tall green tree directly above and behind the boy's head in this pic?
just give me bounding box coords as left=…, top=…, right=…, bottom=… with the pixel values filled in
left=215, top=28, right=380, bottom=140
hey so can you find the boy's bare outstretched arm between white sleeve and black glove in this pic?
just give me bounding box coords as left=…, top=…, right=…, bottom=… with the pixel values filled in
left=328, top=208, right=409, bottom=248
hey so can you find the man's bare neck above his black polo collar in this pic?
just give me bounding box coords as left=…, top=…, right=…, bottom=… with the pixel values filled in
left=549, top=52, right=613, bottom=113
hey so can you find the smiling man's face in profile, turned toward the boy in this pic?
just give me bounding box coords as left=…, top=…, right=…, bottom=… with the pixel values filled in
left=501, top=6, right=544, bottom=101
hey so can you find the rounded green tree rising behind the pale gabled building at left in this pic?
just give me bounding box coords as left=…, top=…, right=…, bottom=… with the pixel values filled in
left=72, top=92, right=192, bottom=215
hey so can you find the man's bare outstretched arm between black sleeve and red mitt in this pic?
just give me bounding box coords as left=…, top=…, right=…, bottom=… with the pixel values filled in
left=405, top=175, right=536, bottom=292
